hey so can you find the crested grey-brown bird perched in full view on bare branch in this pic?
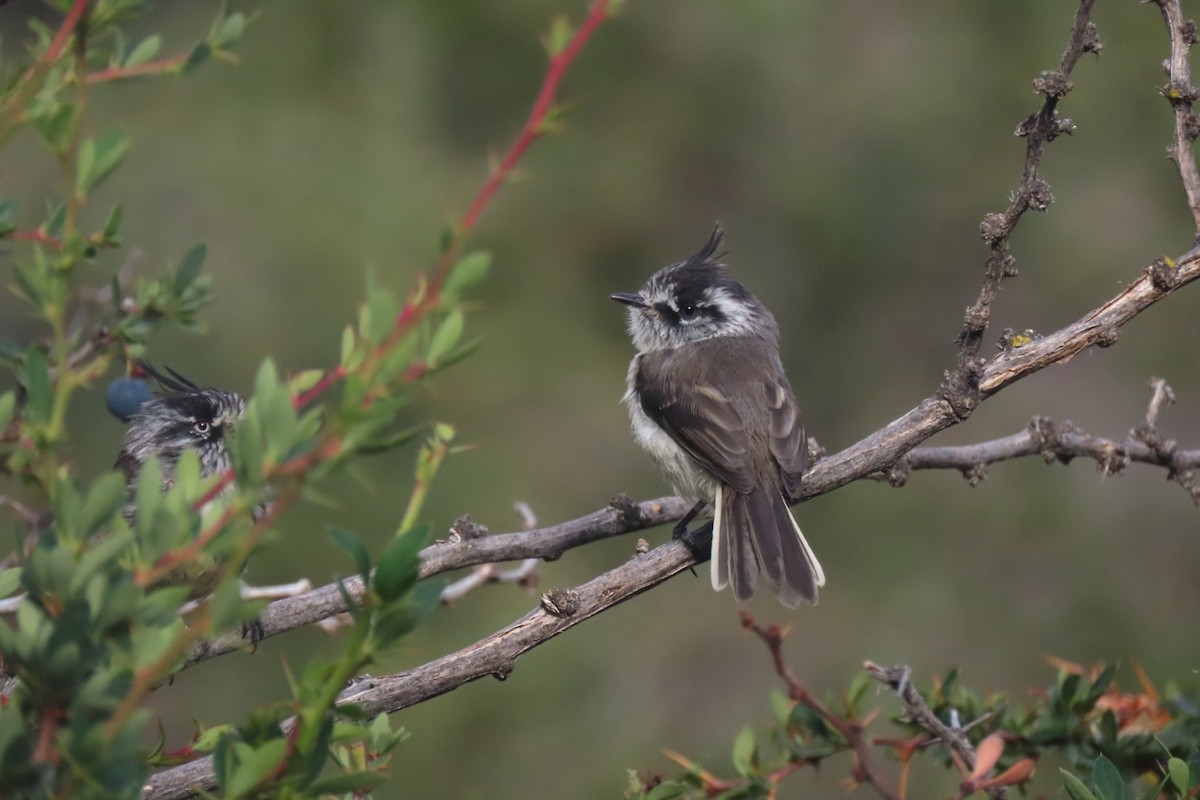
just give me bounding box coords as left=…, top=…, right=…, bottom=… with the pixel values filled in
left=612, top=225, right=824, bottom=608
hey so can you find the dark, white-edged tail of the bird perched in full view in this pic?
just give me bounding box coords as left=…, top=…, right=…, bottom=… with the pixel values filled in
left=713, top=486, right=824, bottom=608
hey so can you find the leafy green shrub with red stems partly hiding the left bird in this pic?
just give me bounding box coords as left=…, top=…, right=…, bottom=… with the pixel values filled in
left=0, top=0, right=488, bottom=798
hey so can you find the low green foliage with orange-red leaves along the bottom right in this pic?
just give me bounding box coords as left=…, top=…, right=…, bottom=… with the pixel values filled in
left=625, top=662, right=1200, bottom=800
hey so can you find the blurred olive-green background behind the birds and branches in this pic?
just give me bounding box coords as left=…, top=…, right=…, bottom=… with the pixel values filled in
left=0, top=0, right=1200, bottom=799
